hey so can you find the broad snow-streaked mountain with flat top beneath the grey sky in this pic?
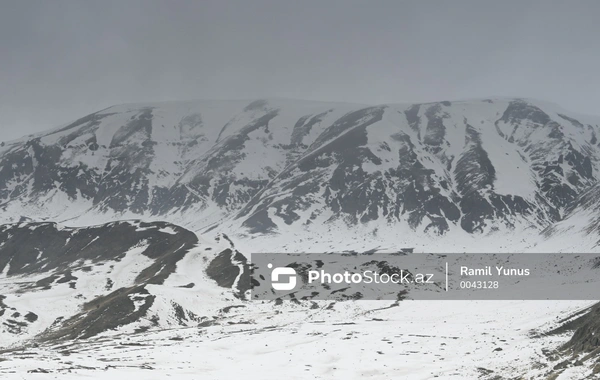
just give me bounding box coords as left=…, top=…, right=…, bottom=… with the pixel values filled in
left=0, top=99, right=600, bottom=249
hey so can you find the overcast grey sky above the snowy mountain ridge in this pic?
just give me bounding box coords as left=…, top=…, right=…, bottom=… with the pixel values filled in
left=0, top=0, right=600, bottom=140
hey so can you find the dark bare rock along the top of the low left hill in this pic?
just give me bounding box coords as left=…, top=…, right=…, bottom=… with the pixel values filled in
left=0, top=222, right=198, bottom=283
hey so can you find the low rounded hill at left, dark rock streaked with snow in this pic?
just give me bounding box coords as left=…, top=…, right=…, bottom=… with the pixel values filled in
left=0, top=221, right=247, bottom=346
